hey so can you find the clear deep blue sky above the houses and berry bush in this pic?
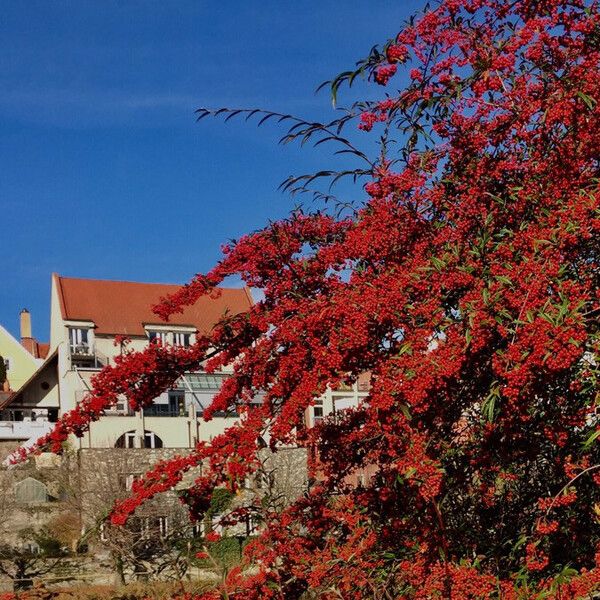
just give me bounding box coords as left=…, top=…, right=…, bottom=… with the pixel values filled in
left=0, top=0, right=424, bottom=340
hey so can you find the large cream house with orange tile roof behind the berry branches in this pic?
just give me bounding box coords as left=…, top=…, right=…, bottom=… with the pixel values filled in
left=4, top=274, right=252, bottom=449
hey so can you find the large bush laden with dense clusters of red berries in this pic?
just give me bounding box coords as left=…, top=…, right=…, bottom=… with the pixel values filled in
left=16, top=0, right=600, bottom=598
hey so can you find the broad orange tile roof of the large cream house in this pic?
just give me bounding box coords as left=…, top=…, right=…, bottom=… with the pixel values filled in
left=54, top=274, right=253, bottom=336
